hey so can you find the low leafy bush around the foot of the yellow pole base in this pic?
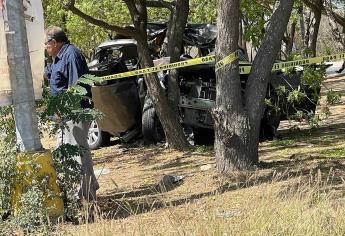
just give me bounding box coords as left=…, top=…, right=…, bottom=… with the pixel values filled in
left=0, top=141, right=49, bottom=235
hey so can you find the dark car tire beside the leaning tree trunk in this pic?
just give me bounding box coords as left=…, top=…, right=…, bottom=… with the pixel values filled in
left=142, top=107, right=158, bottom=145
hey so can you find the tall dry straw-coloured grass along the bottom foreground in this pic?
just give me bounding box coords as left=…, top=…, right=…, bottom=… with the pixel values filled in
left=57, top=171, right=345, bottom=235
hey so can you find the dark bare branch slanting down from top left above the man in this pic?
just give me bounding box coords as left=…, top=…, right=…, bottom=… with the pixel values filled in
left=60, top=0, right=134, bottom=37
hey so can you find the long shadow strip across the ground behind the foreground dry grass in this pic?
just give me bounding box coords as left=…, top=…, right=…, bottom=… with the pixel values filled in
left=98, top=155, right=345, bottom=219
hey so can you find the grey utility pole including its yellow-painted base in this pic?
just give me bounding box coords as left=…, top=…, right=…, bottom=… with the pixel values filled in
left=0, top=0, right=64, bottom=219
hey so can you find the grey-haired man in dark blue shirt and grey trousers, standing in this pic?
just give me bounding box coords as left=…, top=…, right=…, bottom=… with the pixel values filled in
left=45, top=26, right=99, bottom=201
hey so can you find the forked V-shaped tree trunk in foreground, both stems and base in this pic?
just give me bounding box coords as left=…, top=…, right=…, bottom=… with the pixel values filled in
left=213, top=0, right=294, bottom=172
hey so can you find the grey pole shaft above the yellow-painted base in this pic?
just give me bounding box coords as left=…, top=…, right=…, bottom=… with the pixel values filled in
left=4, top=0, right=43, bottom=152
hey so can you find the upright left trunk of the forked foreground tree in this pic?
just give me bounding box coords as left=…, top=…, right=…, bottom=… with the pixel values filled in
left=213, top=0, right=250, bottom=173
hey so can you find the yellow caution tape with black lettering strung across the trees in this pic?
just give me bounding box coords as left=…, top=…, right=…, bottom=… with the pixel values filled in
left=101, top=51, right=345, bottom=80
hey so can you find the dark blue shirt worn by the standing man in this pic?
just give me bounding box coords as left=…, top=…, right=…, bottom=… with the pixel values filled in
left=49, top=43, right=89, bottom=95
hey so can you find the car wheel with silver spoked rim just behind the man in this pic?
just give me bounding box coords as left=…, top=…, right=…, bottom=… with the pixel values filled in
left=87, top=120, right=110, bottom=150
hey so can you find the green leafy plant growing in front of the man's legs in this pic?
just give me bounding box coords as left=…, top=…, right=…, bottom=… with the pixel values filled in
left=40, top=75, right=102, bottom=219
